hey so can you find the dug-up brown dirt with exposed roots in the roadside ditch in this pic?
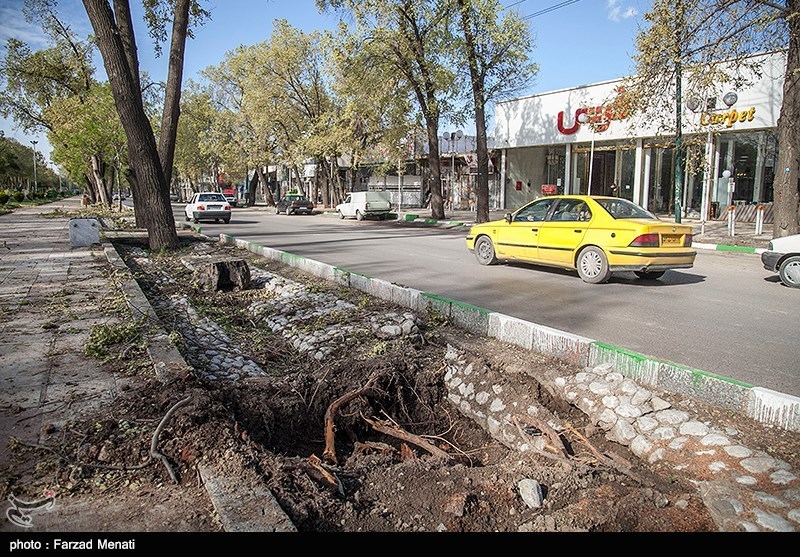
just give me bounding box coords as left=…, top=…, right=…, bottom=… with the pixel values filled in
left=3, top=232, right=797, bottom=532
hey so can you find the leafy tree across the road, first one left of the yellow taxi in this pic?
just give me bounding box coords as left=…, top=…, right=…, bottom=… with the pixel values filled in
left=317, top=0, right=455, bottom=219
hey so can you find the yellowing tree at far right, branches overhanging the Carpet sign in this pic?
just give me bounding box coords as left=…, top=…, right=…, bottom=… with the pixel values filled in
left=621, top=0, right=800, bottom=237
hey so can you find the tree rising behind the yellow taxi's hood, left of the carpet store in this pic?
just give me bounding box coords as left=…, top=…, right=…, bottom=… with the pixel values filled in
left=455, top=0, right=538, bottom=222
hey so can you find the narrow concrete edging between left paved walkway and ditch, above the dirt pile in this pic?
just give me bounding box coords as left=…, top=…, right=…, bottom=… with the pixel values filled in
left=103, top=242, right=192, bottom=383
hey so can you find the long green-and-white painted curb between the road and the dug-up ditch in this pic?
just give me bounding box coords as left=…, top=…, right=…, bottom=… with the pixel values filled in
left=219, top=234, right=800, bottom=431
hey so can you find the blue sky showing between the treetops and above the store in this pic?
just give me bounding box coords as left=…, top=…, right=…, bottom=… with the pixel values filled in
left=0, top=0, right=652, bottom=165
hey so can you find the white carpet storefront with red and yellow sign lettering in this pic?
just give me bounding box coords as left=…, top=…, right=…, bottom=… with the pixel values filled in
left=495, top=52, right=785, bottom=217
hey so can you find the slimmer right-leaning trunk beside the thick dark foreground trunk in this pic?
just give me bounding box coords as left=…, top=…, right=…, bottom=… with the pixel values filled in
left=158, top=0, right=191, bottom=188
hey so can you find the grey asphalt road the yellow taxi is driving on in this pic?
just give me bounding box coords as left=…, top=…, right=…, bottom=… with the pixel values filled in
left=173, top=204, right=800, bottom=396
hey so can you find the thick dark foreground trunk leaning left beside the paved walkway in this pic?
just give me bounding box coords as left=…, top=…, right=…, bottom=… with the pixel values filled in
left=83, top=0, right=178, bottom=250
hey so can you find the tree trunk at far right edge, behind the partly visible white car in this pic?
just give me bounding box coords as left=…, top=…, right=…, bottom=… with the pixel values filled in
left=772, top=0, right=800, bottom=238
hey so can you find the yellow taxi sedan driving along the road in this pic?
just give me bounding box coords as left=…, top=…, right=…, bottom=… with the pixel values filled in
left=467, top=195, right=697, bottom=284
